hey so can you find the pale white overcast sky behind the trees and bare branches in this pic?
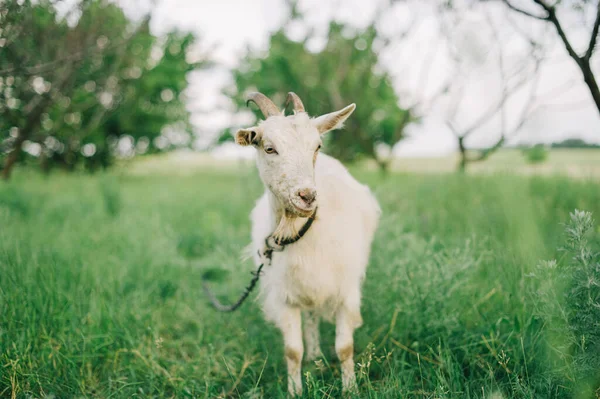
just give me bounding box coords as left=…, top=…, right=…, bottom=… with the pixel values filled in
left=121, top=0, right=600, bottom=156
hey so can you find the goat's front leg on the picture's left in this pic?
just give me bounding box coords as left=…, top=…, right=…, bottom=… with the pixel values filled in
left=281, top=307, right=304, bottom=396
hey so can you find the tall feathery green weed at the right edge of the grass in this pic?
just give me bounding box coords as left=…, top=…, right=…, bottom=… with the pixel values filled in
left=534, top=210, right=600, bottom=397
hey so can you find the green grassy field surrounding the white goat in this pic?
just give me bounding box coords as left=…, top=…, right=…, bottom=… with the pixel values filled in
left=0, top=161, right=600, bottom=398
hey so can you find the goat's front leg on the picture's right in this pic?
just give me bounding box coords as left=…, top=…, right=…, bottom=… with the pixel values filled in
left=335, top=306, right=362, bottom=393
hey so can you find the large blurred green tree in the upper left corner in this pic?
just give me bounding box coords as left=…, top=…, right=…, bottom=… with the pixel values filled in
left=0, top=0, right=201, bottom=178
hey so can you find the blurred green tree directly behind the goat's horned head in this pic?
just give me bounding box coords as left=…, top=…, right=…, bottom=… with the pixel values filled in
left=228, top=23, right=415, bottom=171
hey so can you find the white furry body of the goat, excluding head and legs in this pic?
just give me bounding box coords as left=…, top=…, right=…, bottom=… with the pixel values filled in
left=251, top=154, right=380, bottom=324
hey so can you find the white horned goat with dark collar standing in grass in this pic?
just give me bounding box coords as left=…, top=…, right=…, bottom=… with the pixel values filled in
left=235, top=93, right=381, bottom=395
